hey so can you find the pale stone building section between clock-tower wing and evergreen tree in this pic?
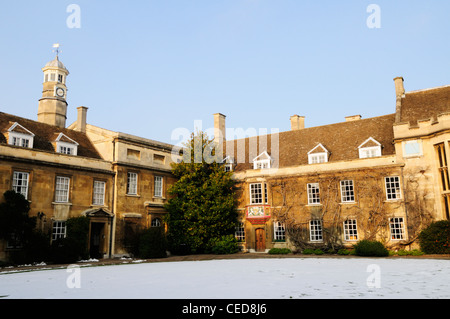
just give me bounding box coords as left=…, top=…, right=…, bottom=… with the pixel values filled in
left=70, top=121, right=177, bottom=256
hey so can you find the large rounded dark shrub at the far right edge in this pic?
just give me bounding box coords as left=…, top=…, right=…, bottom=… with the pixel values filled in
left=419, top=220, right=450, bottom=254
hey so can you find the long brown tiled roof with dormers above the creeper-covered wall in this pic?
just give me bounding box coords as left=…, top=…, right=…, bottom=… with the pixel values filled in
left=226, top=114, right=395, bottom=171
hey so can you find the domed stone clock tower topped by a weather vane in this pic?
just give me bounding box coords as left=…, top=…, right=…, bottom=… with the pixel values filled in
left=38, top=45, right=69, bottom=128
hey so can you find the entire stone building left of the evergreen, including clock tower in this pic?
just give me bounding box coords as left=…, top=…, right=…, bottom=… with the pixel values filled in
left=0, top=55, right=176, bottom=260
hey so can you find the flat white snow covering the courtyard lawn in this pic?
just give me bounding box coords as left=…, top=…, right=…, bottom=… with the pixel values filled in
left=0, top=257, right=450, bottom=299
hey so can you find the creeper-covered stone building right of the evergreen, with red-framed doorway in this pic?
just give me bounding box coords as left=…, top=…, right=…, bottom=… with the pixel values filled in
left=214, top=78, right=450, bottom=251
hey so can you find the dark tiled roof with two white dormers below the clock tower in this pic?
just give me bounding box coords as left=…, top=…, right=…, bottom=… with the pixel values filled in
left=0, top=112, right=101, bottom=159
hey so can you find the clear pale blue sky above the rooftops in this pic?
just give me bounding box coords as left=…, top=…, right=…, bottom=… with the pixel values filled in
left=0, top=0, right=450, bottom=143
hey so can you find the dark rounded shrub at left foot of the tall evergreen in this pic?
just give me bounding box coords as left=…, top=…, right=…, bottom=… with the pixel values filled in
left=137, top=227, right=167, bottom=259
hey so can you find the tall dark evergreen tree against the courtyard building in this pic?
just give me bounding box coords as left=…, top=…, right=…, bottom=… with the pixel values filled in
left=165, top=132, right=237, bottom=254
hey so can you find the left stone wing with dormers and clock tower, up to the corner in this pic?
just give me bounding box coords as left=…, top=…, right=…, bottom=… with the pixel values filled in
left=0, top=56, right=114, bottom=259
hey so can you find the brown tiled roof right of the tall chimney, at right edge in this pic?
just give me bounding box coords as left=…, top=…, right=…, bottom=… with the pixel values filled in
left=400, top=85, right=450, bottom=125
